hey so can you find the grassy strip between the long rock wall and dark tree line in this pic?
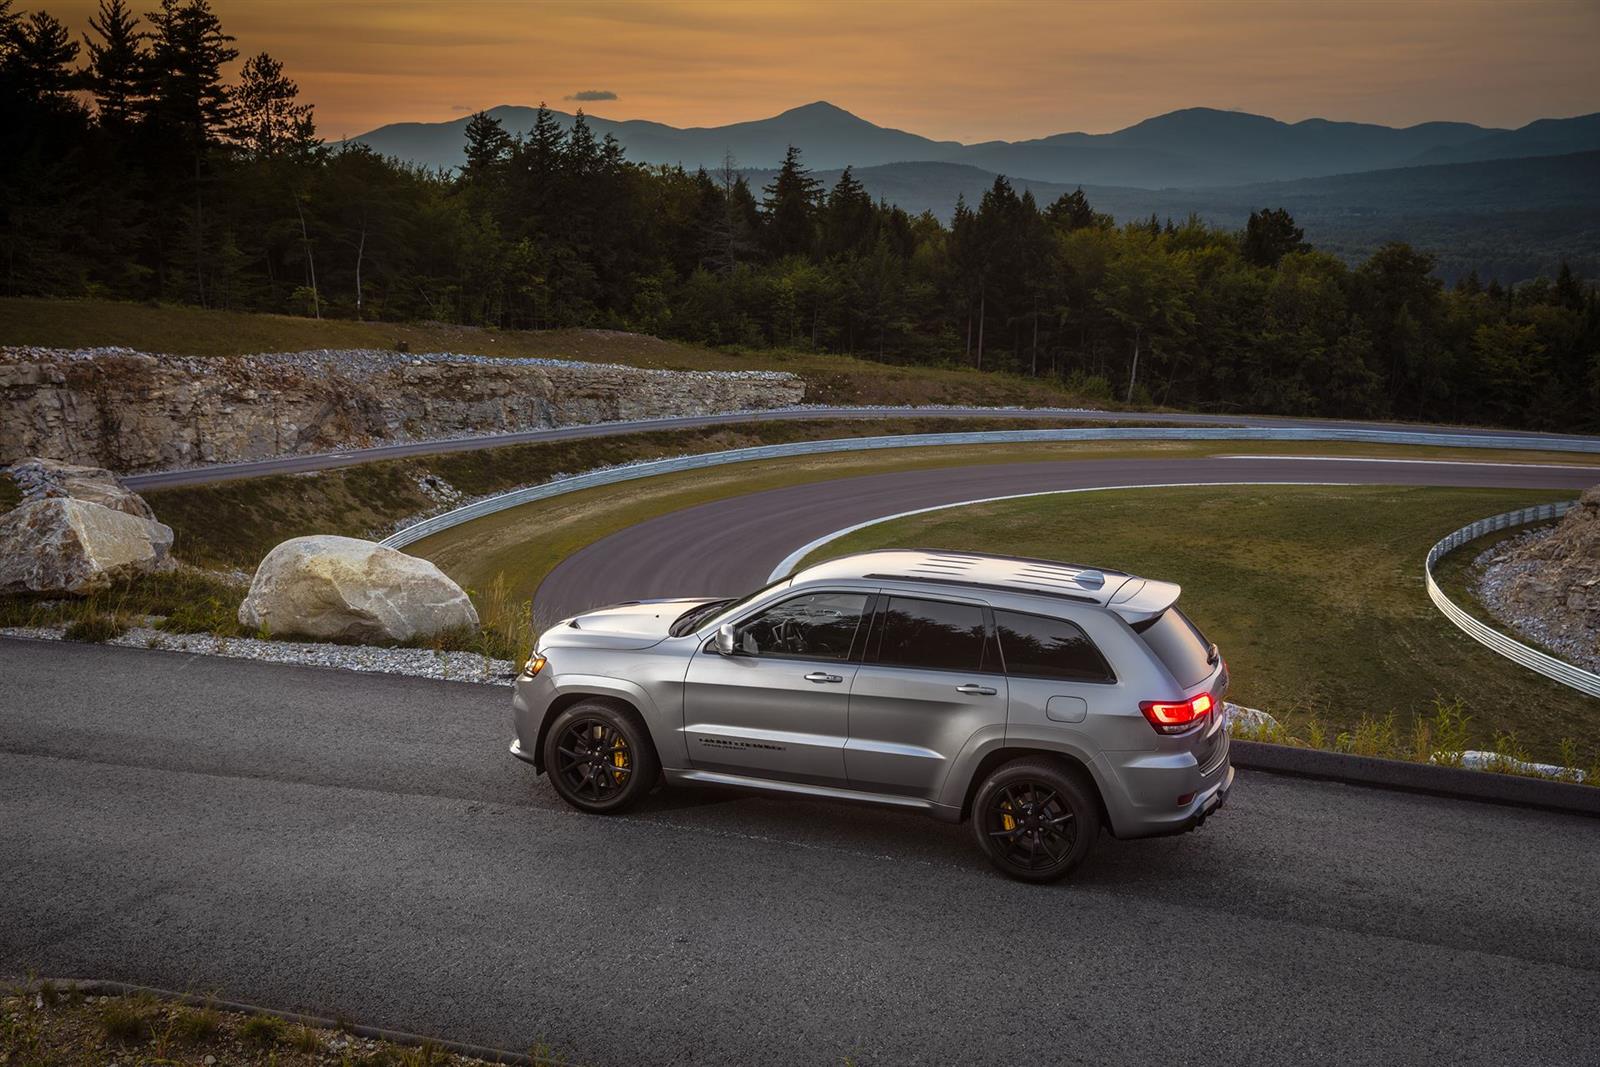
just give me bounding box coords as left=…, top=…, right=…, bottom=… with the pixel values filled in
left=0, top=298, right=1114, bottom=406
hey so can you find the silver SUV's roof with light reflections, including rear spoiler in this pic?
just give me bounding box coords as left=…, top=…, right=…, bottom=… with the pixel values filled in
left=794, top=549, right=1181, bottom=621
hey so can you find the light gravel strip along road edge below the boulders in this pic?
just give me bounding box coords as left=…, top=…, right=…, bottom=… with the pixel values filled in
left=0, top=625, right=517, bottom=685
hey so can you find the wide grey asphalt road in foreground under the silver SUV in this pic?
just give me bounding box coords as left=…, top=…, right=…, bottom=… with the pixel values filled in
left=0, top=640, right=1600, bottom=1065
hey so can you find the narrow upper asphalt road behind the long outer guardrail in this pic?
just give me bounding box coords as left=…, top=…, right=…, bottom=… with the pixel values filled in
left=123, top=408, right=1600, bottom=491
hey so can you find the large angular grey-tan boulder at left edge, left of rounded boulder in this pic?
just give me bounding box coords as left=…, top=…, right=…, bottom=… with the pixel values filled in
left=0, top=496, right=173, bottom=593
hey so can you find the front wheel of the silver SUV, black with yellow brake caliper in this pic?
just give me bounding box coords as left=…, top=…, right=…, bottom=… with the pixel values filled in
left=544, top=701, right=661, bottom=814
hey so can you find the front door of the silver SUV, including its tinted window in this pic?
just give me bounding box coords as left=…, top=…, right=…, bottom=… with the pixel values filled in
left=683, top=592, right=869, bottom=785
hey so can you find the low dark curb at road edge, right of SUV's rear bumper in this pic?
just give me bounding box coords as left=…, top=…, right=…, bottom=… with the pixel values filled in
left=1232, top=737, right=1600, bottom=817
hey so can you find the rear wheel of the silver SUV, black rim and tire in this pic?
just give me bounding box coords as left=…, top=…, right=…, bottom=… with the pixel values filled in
left=973, top=758, right=1101, bottom=881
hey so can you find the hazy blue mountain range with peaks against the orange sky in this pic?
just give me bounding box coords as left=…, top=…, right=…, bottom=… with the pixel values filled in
left=352, top=101, right=1600, bottom=189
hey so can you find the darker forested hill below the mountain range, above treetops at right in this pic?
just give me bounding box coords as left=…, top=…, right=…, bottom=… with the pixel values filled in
left=746, top=150, right=1600, bottom=282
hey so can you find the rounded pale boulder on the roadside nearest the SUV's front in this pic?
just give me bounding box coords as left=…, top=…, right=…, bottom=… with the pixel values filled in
left=238, top=534, right=478, bottom=641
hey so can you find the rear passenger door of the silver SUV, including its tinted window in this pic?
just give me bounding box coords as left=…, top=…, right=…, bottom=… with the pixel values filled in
left=845, top=592, right=1006, bottom=800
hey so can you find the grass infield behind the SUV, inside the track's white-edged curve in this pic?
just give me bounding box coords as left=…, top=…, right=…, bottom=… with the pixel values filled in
left=793, top=486, right=1600, bottom=761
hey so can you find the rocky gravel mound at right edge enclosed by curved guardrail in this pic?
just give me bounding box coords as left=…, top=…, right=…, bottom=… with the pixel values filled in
left=1478, top=486, right=1600, bottom=670
